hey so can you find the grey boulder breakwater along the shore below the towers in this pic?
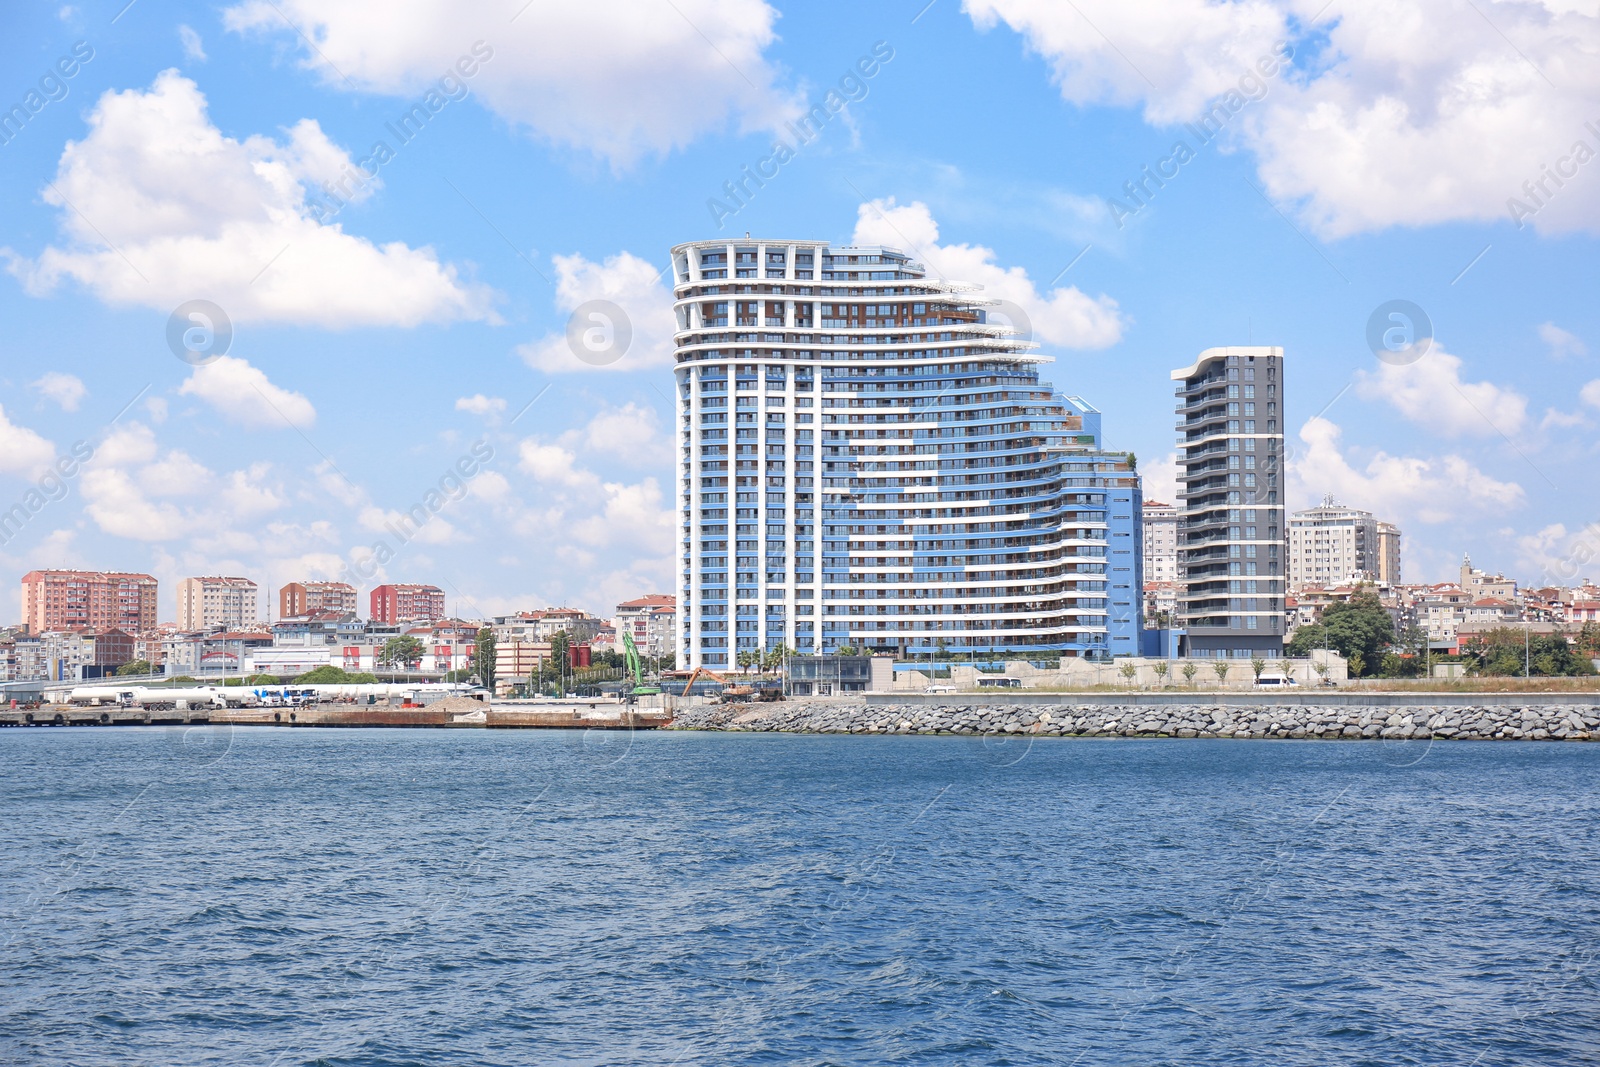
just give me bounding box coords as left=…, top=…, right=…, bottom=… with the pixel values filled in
left=670, top=701, right=1600, bottom=741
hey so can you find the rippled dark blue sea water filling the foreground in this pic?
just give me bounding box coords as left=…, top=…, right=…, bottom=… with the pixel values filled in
left=0, top=728, right=1600, bottom=1067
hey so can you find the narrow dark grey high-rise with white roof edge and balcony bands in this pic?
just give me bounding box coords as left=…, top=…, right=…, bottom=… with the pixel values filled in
left=1173, top=347, right=1288, bottom=657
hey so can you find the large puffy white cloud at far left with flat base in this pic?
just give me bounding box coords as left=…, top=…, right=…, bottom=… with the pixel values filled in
left=6, top=70, right=493, bottom=328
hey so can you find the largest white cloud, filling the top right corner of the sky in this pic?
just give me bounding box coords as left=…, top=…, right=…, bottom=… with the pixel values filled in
left=966, top=0, right=1600, bottom=237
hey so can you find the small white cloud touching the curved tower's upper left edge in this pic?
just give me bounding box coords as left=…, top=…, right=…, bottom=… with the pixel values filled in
left=517, top=251, right=677, bottom=374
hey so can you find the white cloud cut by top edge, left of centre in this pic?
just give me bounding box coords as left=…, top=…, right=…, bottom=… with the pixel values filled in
left=224, top=0, right=797, bottom=166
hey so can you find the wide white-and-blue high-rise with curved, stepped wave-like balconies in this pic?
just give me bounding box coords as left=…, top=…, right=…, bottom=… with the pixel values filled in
left=672, top=238, right=1142, bottom=667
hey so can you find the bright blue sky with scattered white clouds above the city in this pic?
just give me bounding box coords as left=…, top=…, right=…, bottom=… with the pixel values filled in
left=0, top=0, right=1600, bottom=619
